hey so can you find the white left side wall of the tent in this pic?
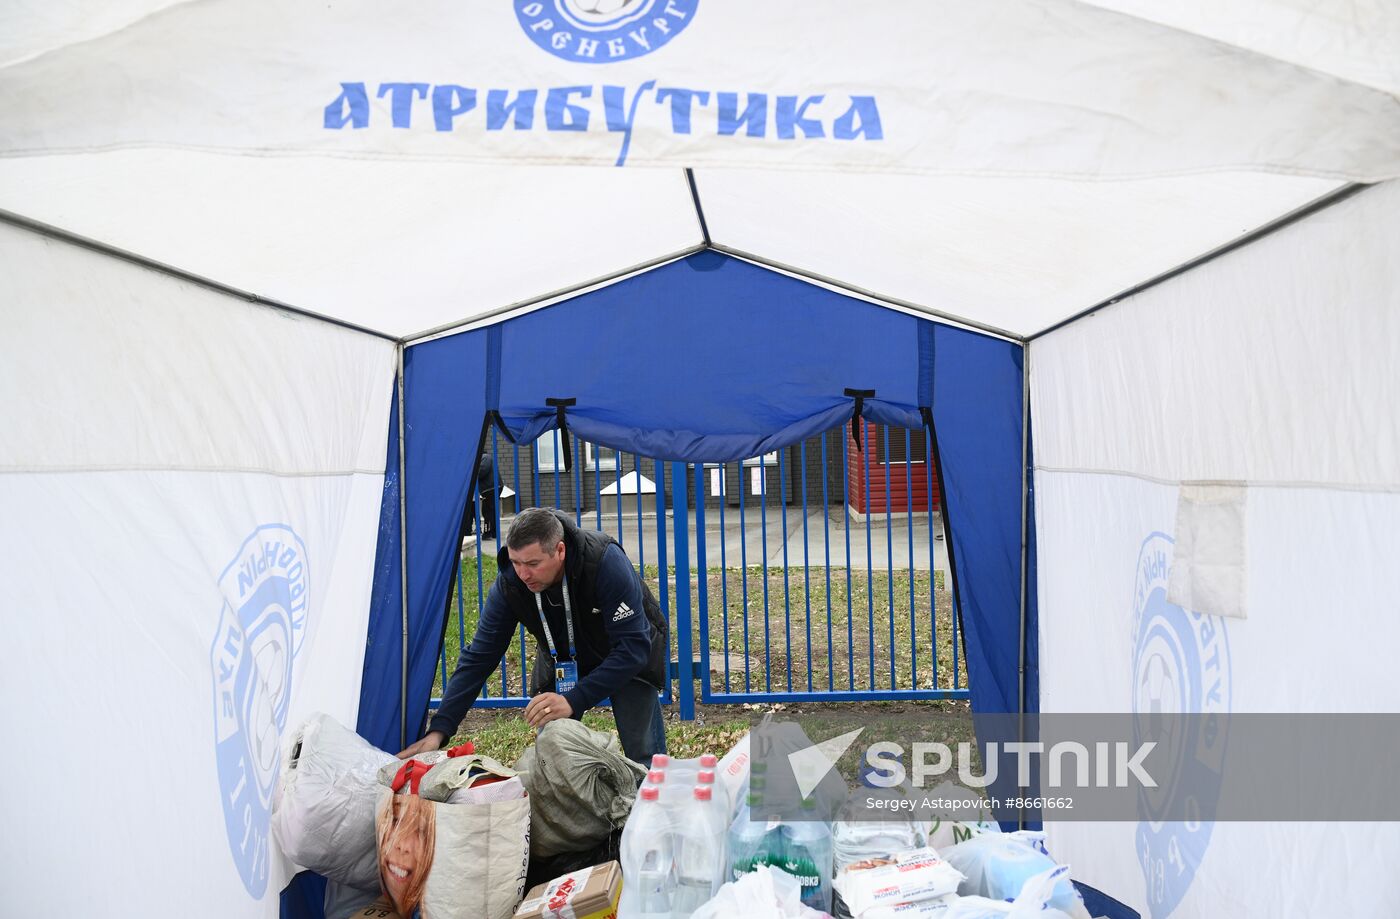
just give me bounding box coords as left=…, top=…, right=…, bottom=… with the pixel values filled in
left=0, top=227, right=393, bottom=916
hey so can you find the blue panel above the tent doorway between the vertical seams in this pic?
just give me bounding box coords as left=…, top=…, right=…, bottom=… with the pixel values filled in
left=500, top=252, right=921, bottom=462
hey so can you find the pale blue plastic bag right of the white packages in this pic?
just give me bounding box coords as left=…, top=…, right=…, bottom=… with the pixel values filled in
left=944, top=829, right=1089, bottom=919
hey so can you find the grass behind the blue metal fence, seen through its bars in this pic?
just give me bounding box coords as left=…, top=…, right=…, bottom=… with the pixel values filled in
left=433, top=558, right=967, bottom=696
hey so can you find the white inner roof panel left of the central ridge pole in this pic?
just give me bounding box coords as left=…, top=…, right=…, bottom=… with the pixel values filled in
left=0, top=150, right=701, bottom=335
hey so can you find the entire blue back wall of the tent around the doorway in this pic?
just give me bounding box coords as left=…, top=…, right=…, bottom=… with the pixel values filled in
left=360, top=252, right=1022, bottom=749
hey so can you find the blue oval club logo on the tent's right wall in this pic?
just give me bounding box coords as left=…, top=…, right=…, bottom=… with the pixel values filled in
left=1133, top=532, right=1231, bottom=919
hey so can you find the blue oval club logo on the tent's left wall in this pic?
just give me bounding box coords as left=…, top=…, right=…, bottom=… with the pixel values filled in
left=209, top=524, right=308, bottom=898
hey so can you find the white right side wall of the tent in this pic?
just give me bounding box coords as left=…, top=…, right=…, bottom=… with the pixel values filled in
left=1030, top=186, right=1400, bottom=918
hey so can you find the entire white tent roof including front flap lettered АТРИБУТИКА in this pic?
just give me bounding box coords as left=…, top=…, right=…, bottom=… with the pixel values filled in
left=0, top=0, right=1400, bottom=338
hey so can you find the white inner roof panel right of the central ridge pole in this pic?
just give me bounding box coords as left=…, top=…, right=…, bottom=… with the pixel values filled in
left=697, top=170, right=1337, bottom=335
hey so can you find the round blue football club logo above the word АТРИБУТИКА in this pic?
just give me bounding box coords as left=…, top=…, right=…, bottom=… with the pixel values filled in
left=515, top=0, right=700, bottom=64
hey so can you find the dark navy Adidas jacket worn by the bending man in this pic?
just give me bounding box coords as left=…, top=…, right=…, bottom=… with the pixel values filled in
left=428, top=511, right=669, bottom=737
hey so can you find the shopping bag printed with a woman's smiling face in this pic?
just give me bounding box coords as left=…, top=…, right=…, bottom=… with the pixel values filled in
left=375, top=759, right=529, bottom=919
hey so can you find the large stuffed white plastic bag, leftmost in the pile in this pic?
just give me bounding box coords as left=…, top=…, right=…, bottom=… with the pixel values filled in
left=272, top=712, right=395, bottom=891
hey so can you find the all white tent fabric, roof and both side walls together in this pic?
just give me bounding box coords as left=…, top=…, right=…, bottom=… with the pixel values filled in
left=0, top=0, right=1400, bottom=919
